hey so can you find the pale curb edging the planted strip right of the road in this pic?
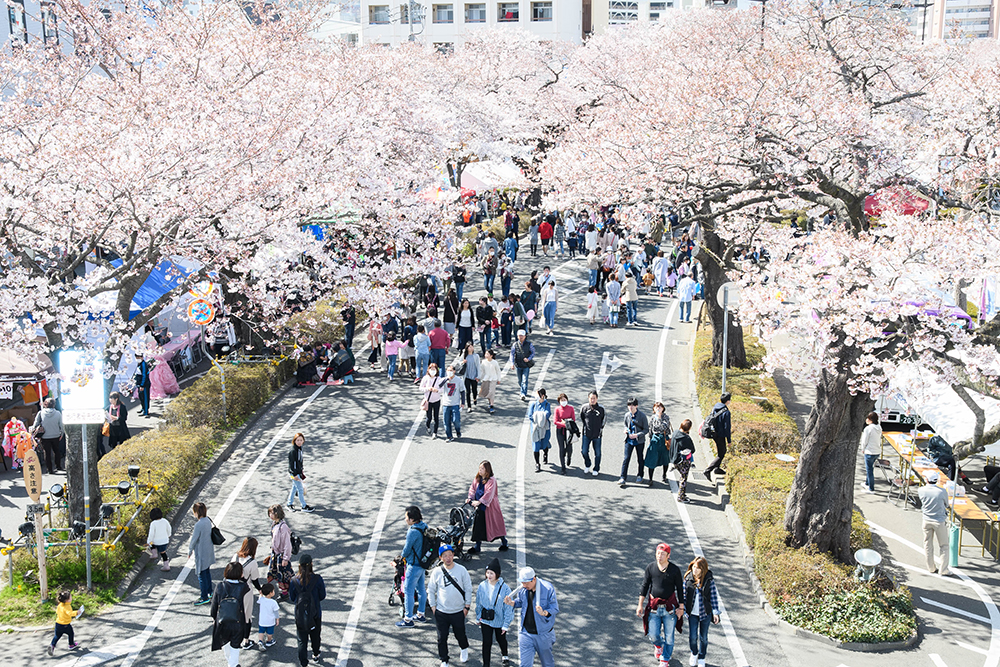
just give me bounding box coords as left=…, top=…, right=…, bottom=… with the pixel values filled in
left=691, top=317, right=920, bottom=653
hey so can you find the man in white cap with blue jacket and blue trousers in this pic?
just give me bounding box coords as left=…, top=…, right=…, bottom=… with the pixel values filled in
left=504, top=567, right=559, bottom=667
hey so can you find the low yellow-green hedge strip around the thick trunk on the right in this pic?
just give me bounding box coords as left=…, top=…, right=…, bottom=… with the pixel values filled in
left=693, top=318, right=916, bottom=643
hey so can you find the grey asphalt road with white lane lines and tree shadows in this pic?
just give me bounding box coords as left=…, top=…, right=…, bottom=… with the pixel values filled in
left=8, top=252, right=1000, bottom=667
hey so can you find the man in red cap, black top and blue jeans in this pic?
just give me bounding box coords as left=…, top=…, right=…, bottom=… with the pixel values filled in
left=635, top=542, right=684, bottom=667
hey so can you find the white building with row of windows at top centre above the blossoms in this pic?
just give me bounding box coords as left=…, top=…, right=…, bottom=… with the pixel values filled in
left=361, top=0, right=590, bottom=51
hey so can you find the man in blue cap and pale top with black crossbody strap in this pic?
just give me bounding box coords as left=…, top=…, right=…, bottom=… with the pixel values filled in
left=427, top=544, right=472, bottom=667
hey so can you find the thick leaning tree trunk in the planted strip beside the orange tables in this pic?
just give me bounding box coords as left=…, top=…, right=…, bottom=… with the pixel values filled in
left=785, top=358, right=874, bottom=563
